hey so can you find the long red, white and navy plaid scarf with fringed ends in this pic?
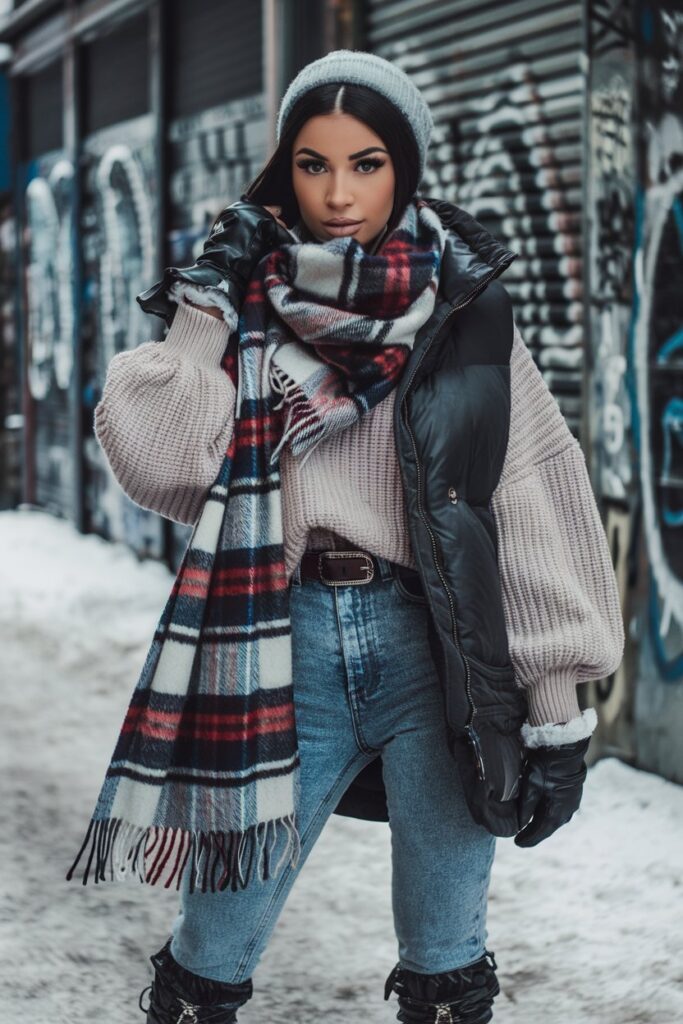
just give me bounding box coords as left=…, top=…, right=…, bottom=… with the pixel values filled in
left=67, top=200, right=445, bottom=892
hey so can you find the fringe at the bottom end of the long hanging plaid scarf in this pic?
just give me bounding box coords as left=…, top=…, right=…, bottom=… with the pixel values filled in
left=67, top=814, right=301, bottom=893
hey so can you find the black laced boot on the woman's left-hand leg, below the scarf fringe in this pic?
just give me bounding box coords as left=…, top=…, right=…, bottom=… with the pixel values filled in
left=138, top=939, right=253, bottom=1024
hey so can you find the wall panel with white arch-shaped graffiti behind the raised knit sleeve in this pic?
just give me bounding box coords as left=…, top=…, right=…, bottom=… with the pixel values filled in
left=80, top=115, right=163, bottom=557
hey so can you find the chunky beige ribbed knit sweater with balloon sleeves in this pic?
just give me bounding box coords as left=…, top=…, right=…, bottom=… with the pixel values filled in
left=94, top=302, right=625, bottom=738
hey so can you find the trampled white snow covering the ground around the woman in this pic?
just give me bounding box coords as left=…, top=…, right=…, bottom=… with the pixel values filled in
left=0, top=510, right=683, bottom=1024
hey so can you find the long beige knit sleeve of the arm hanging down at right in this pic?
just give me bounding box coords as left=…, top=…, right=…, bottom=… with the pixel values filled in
left=492, top=325, right=625, bottom=729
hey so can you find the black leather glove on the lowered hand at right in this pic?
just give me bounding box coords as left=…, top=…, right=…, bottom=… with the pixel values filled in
left=515, top=736, right=591, bottom=846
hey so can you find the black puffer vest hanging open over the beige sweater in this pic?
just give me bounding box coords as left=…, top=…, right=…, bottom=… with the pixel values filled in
left=335, top=197, right=527, bottom=836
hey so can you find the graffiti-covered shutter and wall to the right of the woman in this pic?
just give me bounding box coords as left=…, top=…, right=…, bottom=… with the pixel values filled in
left=369, top=0, right=683, bottom=780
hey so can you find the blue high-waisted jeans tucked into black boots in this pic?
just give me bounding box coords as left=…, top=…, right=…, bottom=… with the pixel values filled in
left=166, top=559, right=496, bottom=983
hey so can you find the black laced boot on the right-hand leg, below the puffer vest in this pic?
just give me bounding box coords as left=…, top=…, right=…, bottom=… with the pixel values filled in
left=384, top=949, right=501, bottom=1024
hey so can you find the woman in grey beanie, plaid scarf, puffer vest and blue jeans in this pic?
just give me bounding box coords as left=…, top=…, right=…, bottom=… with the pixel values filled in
left=68, top=50, right=624, bottom=1024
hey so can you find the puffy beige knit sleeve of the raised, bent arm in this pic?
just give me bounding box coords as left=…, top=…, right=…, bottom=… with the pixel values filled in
left=94, top=302, right=236, bottom=524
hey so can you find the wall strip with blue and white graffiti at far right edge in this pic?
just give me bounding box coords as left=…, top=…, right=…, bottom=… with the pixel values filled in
left=633, top=0, right=683, bottom=781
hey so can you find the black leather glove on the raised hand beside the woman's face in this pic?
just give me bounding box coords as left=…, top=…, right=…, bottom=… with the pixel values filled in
left=135, top=199, right=295, bottom=327
